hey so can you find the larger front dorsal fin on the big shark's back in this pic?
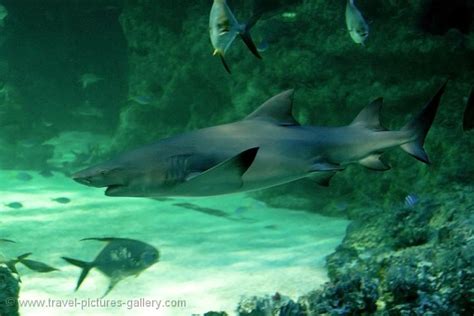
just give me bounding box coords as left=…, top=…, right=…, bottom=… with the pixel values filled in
left=245, top=89, right=300, bottom=126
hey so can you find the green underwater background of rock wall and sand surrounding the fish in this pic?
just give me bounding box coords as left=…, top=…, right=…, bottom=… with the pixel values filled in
left=0, top=0, right=474, bottom=316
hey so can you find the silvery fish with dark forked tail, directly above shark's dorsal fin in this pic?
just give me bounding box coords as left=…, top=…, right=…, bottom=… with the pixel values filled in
left=209, top=0, right=262, bottom=73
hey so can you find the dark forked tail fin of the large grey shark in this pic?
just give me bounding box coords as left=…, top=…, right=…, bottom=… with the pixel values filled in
left=401, top=81, right=447, bottom=164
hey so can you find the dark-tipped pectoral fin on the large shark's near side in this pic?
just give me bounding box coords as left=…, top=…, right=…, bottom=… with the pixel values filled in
left=180, top=147, right=259, bottom=188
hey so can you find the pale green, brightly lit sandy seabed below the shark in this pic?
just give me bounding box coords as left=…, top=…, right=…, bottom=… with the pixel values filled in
left=0, top=170, right=348, bottom=316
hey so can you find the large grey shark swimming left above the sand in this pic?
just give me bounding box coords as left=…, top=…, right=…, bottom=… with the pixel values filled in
left=72, top=81, right=447, bottom=198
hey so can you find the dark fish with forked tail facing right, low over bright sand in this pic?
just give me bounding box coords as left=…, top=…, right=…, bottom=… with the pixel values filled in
left=62, top=237, right=160, bottom=297
